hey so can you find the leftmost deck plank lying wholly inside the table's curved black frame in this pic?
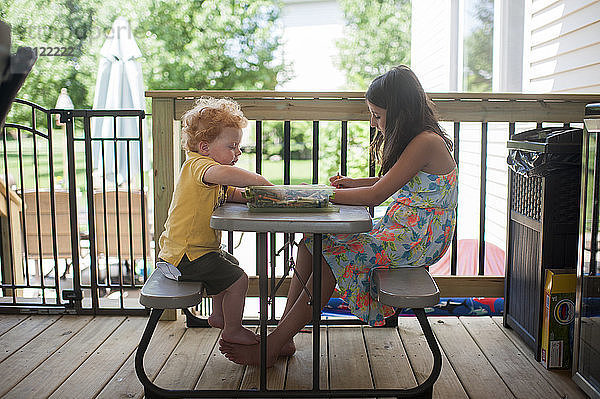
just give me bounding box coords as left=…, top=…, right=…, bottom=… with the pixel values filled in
left=154, top=328, right=221, bottom=389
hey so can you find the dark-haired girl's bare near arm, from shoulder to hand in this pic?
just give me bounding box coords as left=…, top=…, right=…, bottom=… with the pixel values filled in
left=333, top=133, right=438, bottom=206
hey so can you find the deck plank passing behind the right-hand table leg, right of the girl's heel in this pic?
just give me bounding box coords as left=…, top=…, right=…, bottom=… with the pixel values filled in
left=285, top=327, right=329, bottom=390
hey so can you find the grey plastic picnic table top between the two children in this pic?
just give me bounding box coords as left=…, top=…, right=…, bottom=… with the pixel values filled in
left=210, top=203, right=372, bottom=234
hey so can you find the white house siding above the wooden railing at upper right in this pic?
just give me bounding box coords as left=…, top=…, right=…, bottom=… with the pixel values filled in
left=525, top=0, right=600, bottom=93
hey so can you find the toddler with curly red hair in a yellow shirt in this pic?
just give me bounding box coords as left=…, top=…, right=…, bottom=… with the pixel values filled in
left=159, top=98, right=271, bottom=345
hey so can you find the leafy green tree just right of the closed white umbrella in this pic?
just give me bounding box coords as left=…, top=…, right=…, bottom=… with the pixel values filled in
left=140, top=0, right=286, bottom=90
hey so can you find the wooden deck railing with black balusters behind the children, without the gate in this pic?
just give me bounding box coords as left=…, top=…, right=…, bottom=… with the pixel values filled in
left=146, top=90, right=600, bottom=297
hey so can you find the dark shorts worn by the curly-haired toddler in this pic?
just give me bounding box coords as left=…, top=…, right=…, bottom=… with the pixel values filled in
left=177, top=251, right=245, bottom=295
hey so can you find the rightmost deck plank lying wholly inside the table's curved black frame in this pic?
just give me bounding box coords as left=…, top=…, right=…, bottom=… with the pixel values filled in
left=363, top=327, right=417, bottom=389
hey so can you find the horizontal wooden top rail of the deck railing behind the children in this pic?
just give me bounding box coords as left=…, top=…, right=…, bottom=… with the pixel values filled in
left=146, top=90, right=600, bottom=123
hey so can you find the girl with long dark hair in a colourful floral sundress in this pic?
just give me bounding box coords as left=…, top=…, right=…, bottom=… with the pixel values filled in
left=221, top=65, right=457, bottom=365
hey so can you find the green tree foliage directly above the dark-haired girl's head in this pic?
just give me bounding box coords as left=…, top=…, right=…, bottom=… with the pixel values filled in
left=337, top=0, right=411, bottom=90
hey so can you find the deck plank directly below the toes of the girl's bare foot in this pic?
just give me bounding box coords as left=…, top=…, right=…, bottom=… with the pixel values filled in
left=195, top=330, right=246, bottom=390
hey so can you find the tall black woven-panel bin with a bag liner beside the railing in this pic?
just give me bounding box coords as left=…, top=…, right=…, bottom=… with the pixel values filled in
left=504, top=128, right=583, bottom=360
